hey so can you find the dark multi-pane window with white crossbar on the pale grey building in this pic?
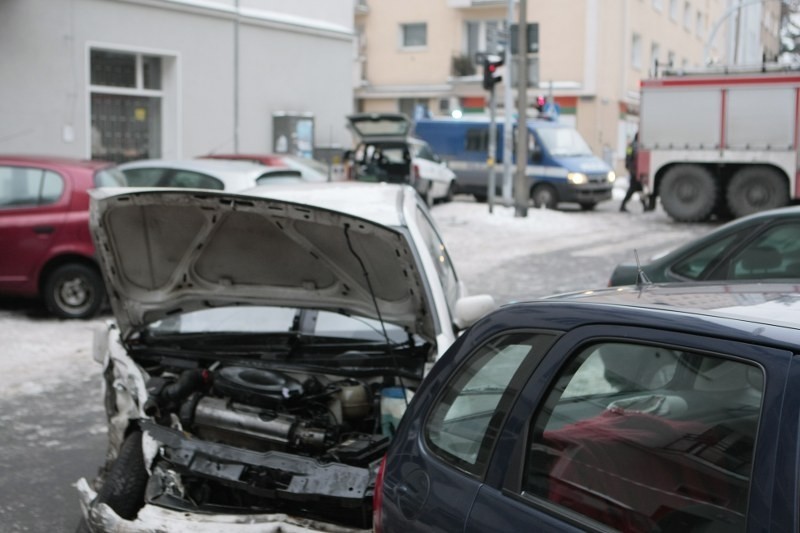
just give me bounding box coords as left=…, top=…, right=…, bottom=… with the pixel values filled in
left=89, top=50, right=163, bottom=163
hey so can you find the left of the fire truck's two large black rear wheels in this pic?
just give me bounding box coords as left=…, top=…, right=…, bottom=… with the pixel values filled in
left=659, top=165, right=719, bottom=222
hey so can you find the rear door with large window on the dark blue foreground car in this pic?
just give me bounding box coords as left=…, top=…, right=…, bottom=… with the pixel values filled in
left=465, top=326, right=797, bottom=532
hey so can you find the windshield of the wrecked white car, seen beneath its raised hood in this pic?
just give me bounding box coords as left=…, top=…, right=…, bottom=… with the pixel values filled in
left=144, top=306, right=416, bottom=343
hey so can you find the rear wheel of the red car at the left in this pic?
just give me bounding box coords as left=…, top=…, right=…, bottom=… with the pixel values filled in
left=43, top=263, right=106, bottom=318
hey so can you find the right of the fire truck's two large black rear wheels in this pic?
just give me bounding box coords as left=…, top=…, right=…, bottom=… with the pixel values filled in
left=726, top=166, right=789, bottom=217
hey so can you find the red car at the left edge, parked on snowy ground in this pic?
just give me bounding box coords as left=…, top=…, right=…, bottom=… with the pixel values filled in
left=0, top=156, right=126, bottom=318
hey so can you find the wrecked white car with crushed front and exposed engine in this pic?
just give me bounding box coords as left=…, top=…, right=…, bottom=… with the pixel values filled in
left=77, top=183, right=494, bottom=533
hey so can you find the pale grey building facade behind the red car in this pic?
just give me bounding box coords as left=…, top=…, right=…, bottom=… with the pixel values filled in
left=0, top=0, right=353, bottom=161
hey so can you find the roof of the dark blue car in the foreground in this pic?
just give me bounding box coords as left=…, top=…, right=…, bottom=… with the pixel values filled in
left=482, top=282, right=800, bottom=353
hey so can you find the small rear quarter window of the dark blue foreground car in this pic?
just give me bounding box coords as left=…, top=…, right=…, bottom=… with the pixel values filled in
left=425, top=333, right=555, bottom=474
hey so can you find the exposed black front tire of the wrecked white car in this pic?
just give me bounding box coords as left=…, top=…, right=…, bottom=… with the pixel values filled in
left=95, top=431, right=147, bottom=520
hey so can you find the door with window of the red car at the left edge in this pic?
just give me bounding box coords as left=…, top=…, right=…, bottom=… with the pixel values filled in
left=0, top=166, right=71, bottom=292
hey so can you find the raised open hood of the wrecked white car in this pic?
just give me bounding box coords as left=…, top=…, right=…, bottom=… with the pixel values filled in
left=90, top=189, right=435, bottom=340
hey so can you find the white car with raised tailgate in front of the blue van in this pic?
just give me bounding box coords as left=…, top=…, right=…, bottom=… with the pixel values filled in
left=347, top=113, right=456, bottom=205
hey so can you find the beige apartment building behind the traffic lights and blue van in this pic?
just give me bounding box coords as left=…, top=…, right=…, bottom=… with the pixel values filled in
left=355, top=0, right=780, bottom=169
